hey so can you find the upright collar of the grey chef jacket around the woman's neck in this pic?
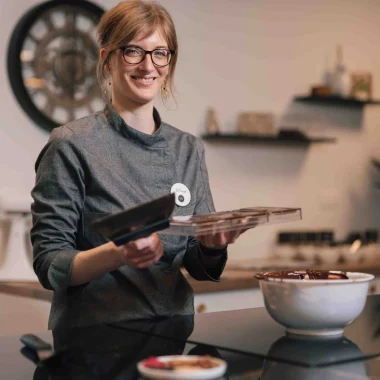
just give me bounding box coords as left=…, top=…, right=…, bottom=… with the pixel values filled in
left=104, top=105, right=167, bottom=148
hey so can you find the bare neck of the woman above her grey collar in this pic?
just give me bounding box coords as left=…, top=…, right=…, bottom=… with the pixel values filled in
left=112, top=100, right=156, bottom=135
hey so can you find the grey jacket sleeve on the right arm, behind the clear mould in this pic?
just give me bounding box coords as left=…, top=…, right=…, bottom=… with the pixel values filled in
left=183, top=139, right=227, bottom=282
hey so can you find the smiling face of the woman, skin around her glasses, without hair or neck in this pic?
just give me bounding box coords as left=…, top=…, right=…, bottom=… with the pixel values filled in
left=105, top=30, right=169, bottom=105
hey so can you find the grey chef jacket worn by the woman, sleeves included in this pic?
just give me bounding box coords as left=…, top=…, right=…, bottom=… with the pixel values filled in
left=31, top=106, right=227, bottom=329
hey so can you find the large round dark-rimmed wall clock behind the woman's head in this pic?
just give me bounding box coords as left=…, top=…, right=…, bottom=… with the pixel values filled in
left=7, top=0, right=104, bottom=131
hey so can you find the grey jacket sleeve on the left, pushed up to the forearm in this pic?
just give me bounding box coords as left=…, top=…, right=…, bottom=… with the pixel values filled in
left=31, top=127, right=85, bottom=291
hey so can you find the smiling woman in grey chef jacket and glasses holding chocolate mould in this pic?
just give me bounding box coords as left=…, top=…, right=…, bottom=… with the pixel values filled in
left=31, top=1, right=243, bottom=328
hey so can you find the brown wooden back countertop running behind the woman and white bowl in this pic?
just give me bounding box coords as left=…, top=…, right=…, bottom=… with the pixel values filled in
left=0, top=260, right=380, bottom=301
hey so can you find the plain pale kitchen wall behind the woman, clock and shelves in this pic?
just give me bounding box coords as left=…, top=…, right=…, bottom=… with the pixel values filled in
left=0, top=0, right=380, bottom=270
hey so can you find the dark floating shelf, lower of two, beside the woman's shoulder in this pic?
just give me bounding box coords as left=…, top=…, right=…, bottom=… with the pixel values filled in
left=201, top=133, right=336, bottom=145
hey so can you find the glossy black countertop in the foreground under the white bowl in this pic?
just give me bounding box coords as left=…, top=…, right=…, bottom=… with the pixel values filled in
left=0, top=296, right=380, bottom=380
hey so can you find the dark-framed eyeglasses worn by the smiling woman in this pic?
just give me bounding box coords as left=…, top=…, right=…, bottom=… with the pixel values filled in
left=120, top=46, right=175, bottom=67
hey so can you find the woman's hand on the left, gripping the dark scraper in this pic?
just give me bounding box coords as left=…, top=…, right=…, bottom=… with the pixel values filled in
left=115, top=233, right=164, bottom=269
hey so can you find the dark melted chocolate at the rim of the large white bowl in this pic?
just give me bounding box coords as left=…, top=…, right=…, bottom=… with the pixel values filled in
left=255, top=269, right=348, bottom=280
